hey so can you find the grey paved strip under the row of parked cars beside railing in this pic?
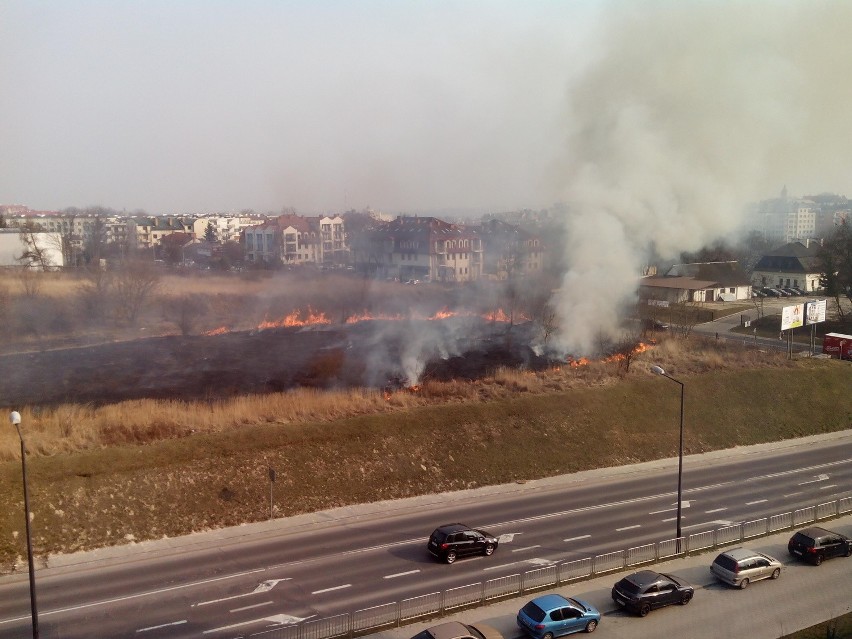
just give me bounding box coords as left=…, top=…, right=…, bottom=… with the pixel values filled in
left=371, top=515, right=852, bottom=639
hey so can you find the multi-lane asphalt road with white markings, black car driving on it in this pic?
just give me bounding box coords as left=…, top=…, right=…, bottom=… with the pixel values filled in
left=0, top=431, right=852, bottom=639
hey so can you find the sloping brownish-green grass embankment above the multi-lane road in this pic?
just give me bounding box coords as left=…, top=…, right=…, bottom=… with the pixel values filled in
left=0, top=348, right=852, bottom=570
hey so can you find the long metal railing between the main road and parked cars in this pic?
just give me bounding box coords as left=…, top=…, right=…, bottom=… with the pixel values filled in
left=256, top=497, right=852, bottom=639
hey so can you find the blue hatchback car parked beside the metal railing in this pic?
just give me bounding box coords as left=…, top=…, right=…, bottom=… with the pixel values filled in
left=518, top=595, right=601, bottom=639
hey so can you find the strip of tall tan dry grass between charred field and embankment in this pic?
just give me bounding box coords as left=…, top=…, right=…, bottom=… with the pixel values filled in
left=0, top=337, right=795, bottom=461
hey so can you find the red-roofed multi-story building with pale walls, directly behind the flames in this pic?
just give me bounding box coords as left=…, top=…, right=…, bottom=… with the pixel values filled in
left=355, top=217, right=483, bottom=282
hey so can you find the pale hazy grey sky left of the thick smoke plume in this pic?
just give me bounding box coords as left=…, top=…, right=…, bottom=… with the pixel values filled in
left=0, top=0, right=601, bottom=213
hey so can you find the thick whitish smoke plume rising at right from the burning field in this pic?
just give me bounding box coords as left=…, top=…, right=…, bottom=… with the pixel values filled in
left=556, top=2, right=852, bottom=354
